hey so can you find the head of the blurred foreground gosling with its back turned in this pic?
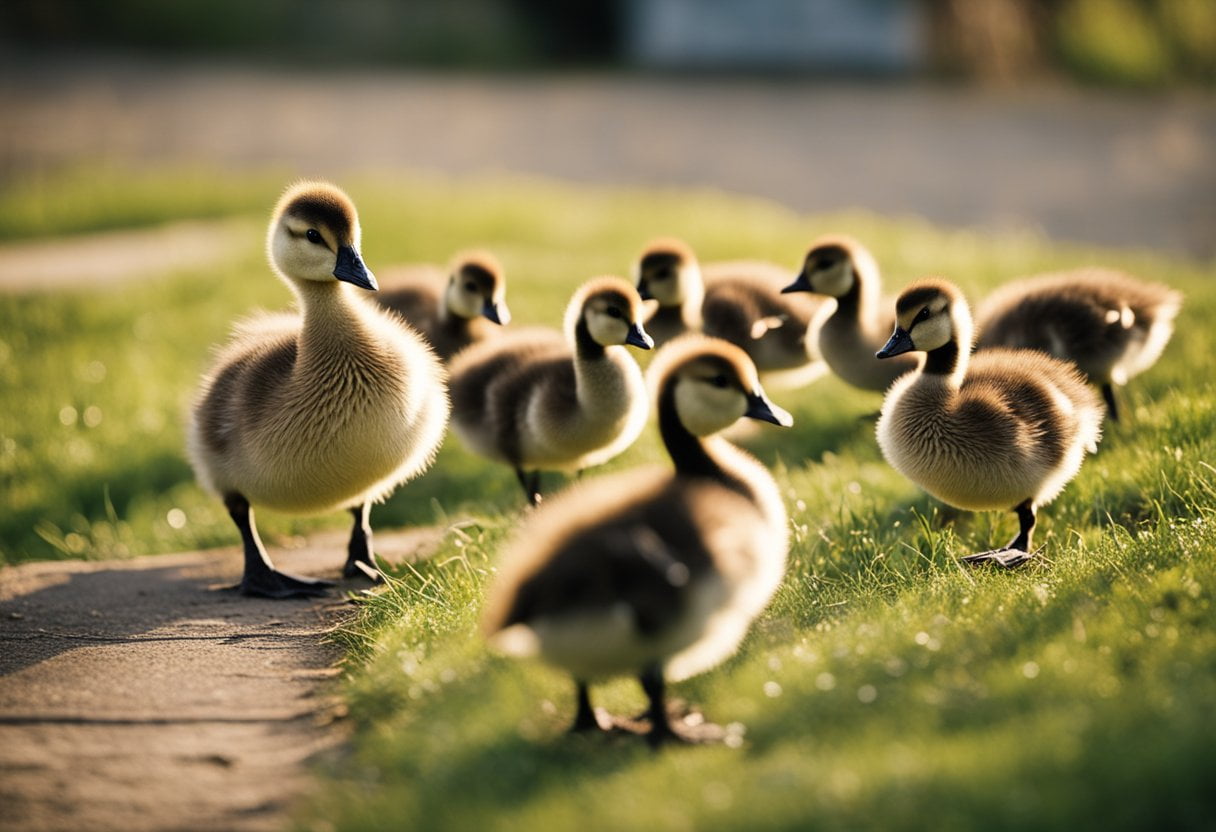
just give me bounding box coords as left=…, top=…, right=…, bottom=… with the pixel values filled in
left=649, top=333, right=794, bottom=437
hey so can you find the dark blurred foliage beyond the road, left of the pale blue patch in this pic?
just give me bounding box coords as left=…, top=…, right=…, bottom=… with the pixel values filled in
left=0, top=0, right=612, bottom=67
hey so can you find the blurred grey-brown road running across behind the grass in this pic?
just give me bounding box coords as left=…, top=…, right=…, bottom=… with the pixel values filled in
left=7, top=61, right=1216, bottom=257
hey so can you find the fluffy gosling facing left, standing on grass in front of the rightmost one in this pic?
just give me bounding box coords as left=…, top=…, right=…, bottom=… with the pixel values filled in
left=878, top=279, right=1103, bottom=568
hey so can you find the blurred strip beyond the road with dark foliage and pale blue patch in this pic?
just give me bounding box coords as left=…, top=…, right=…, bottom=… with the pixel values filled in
left=0, top=0, right=1216, bottom=85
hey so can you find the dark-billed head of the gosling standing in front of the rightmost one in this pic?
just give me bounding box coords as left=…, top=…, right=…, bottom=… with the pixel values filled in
left=877, top=277, right=972, bottom=359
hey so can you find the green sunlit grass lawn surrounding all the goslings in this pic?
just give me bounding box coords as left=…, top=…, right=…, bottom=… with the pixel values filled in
left=0, top=165, right=1216, bottom=831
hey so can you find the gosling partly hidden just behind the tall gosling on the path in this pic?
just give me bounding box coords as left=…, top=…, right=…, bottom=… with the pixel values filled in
left=376, top=252, right=511, bottom=361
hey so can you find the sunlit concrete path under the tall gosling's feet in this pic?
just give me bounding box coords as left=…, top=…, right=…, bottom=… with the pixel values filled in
left=0, top=529, right=438, bottom=832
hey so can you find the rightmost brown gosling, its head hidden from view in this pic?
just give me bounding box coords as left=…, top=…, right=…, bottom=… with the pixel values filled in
left=975, top=268, right=1182, bottom=421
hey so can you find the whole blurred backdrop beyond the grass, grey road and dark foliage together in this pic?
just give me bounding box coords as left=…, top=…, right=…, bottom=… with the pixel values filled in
left=0, top=0, right=1216, bottom=257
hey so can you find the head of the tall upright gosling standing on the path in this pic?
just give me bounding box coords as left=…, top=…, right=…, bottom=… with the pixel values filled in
left=266, top=181, right=379, bottom=292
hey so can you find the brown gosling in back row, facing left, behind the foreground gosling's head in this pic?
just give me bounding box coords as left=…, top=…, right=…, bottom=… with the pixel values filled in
left=635, top=237, right=829, bottom=389
